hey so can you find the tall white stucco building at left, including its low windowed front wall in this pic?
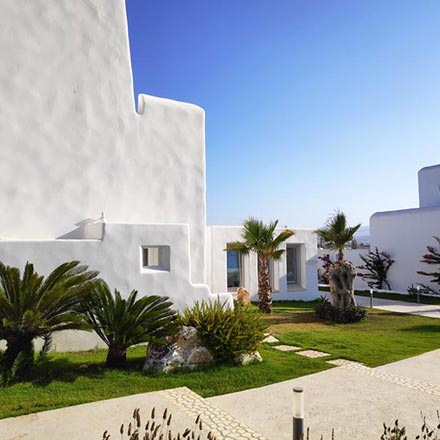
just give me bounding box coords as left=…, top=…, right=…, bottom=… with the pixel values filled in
left=0, top=0, right=317, bottom=348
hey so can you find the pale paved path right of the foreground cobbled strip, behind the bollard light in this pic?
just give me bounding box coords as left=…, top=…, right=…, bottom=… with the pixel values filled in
left=208, top=350, right=440, bottom=440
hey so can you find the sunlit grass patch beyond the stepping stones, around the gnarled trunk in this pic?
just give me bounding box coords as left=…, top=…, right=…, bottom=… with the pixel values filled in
left=269, top=302, right=440, bottom=367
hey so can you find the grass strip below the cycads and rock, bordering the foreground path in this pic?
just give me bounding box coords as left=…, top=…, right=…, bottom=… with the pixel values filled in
left=0, top=344, right=331, bottom=418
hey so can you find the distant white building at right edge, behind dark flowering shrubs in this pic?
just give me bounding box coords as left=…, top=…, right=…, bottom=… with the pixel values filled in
left=370, top=165, right=440, bottom=292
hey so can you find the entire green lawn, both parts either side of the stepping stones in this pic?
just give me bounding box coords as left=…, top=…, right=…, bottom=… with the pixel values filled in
left=0, top=302, right=440, bottom=418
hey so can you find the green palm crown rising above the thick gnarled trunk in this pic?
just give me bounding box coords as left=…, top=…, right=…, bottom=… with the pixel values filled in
left=315, top=210, right=361, bottom=261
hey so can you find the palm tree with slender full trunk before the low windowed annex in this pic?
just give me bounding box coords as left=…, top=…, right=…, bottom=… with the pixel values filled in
left=226, top=217, right=294, bottom=313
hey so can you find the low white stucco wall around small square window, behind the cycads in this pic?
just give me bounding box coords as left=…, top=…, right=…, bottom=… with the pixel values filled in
left=0, top=224, right=227, bottom=350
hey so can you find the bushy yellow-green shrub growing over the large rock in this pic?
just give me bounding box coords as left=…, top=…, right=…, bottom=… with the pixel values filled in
left=179, top=300, right=267, bottom=363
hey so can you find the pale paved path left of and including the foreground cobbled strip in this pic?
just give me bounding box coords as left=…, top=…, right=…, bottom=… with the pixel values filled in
left=0, top=387, right=267, bottom=440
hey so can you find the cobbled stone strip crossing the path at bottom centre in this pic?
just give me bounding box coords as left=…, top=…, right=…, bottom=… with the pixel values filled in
left=159, top=387, right=268, bottom=440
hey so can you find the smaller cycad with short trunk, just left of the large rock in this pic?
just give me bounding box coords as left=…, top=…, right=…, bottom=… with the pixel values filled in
left=85, top=281, right=177, bottom=368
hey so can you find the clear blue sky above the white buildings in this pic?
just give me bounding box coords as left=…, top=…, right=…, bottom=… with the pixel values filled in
left=126, top=0, right=440, bottom=228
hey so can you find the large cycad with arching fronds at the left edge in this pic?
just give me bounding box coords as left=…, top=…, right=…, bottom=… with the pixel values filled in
left=0, top=261, right=98, bottom=377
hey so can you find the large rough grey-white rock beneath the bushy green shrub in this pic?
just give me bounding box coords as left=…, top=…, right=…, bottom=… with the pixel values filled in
left=143, top=327, right=214, bottom=373
